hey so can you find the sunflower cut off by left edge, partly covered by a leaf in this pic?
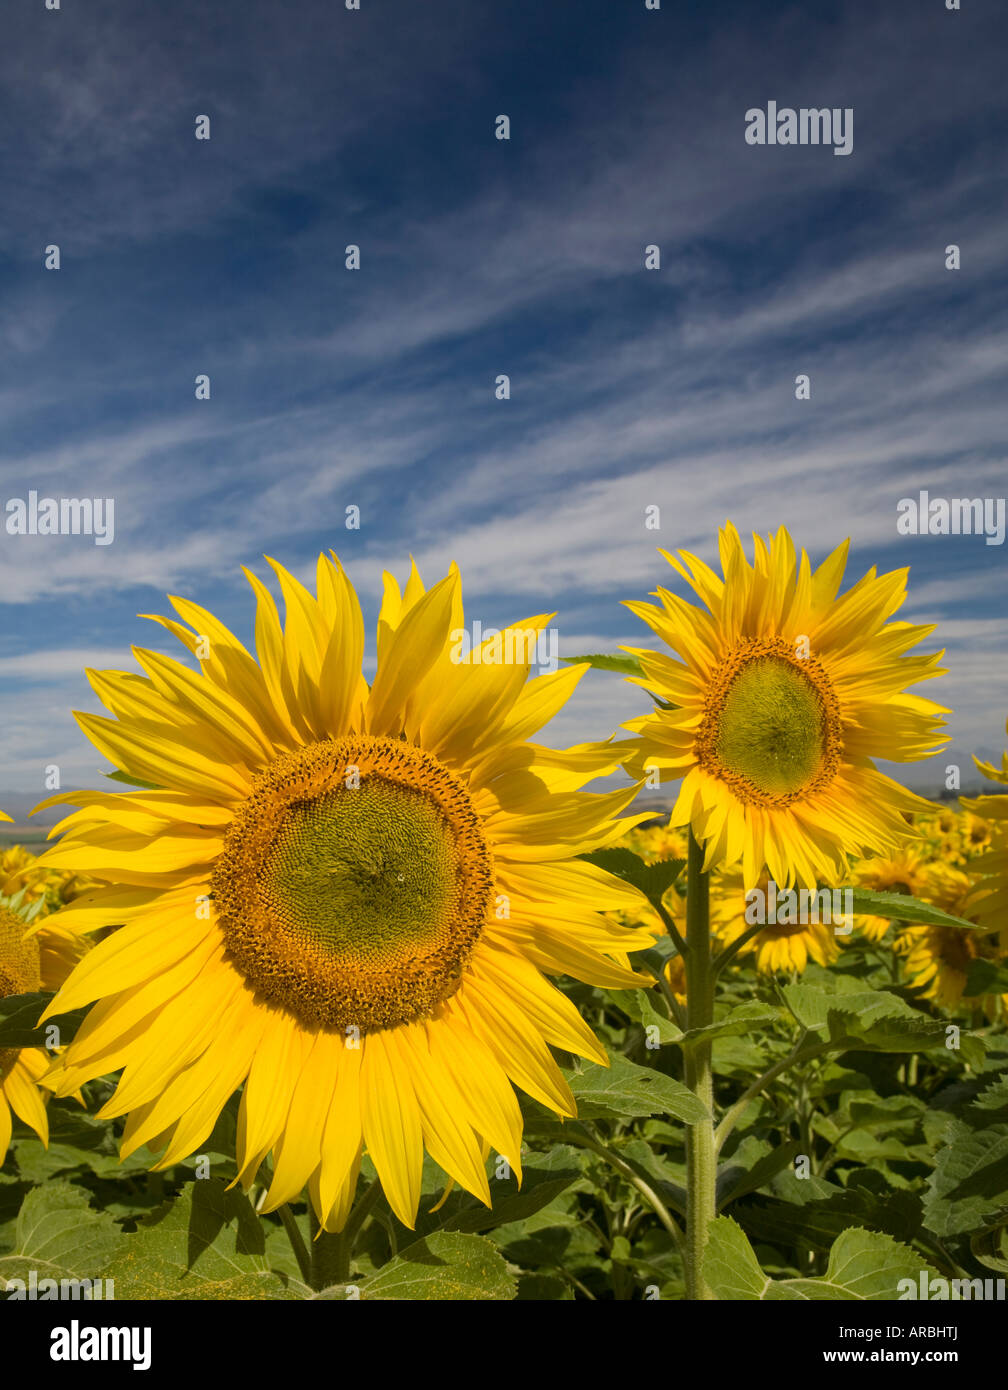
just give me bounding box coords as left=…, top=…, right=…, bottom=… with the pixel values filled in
left=0, top=889, right=83, bottom=1163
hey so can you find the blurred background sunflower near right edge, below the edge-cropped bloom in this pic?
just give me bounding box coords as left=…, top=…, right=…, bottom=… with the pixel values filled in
left=897, top=865, right=1008, bottom=1019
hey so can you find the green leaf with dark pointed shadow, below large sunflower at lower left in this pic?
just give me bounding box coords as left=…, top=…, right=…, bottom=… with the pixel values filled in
left=107, top=1179, right=309, bottom=1300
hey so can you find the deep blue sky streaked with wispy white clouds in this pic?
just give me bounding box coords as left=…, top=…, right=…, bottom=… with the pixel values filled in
left=0, top=0, right=1008, bottom=805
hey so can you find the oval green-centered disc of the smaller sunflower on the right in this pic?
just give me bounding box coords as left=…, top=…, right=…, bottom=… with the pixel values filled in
left=715, top=657, right=826, bottom=795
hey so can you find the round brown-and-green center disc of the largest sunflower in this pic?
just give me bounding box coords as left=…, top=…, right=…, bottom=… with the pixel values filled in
left=213, top=734, right=494, bottom=1033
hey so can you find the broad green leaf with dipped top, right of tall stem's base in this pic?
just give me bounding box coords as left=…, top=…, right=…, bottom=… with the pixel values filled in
left=704, top=1216, right=936, bottom=1301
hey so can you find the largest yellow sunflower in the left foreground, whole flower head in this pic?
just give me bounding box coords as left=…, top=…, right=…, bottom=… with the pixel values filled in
left=35, top=556, right=652, bottom=1230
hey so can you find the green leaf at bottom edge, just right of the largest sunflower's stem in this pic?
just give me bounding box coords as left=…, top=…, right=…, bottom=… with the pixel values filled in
left=360, top=1230, right=517, bottom=1302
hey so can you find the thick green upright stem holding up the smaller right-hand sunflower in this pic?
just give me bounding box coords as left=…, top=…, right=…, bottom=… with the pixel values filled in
left=684, top=830, right=717, bottom=1300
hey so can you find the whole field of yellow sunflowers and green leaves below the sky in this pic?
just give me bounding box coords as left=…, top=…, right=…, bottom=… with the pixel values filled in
left=0, top=525, right=1008, bottom=1301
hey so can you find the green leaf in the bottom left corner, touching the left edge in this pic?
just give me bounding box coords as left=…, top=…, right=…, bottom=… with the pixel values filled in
left=0, top=1182, right=124, bottom=1283
